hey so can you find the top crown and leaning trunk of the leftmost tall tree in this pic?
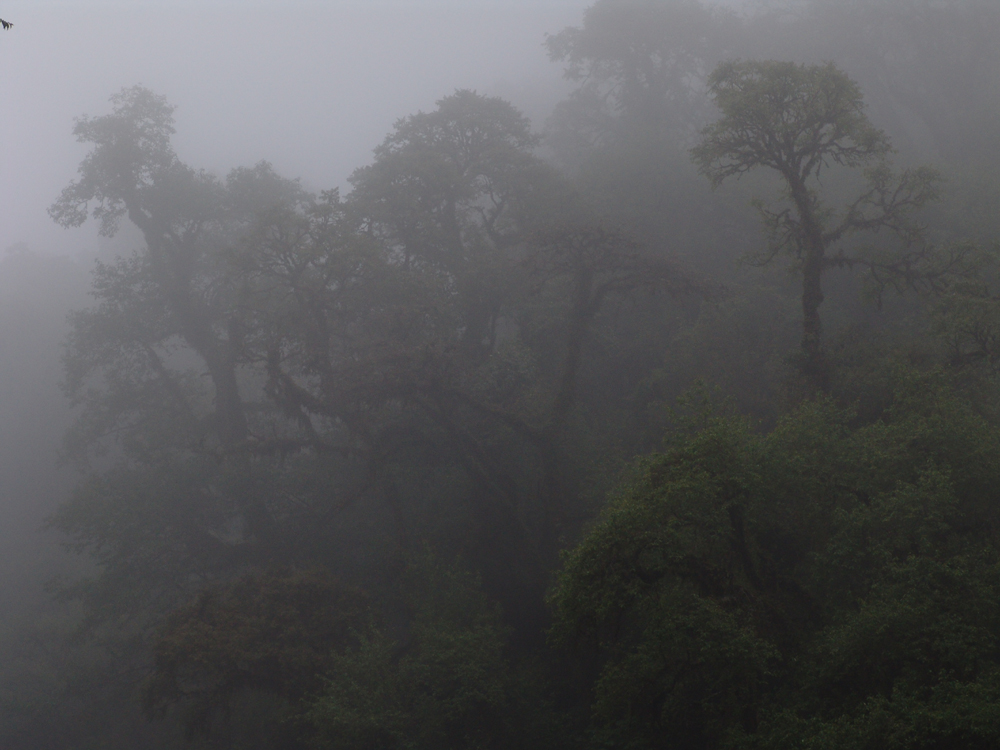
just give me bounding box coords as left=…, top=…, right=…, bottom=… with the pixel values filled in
left=49, top=86, right=295, bottom=464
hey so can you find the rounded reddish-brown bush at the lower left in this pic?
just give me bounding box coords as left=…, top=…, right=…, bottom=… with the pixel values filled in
left=145, top=571, right=367, bottom=736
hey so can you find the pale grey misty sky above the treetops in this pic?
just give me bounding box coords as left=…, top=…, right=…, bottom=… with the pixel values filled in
left=0, top=0, right=590, bottom=252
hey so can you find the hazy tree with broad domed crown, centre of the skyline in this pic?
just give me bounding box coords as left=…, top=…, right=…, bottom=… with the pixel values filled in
left=348, top=90, right=557, bottom=356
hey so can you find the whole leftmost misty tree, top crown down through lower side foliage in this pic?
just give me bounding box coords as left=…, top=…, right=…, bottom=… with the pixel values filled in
left=50, top=87, right=332, bottom=664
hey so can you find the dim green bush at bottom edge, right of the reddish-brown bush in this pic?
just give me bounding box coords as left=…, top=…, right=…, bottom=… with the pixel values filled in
left=308, top=553, right=537, bottom=750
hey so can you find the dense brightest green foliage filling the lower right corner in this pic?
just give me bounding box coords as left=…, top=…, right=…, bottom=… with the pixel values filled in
left=552, top=370, right=1000, bottom=748
